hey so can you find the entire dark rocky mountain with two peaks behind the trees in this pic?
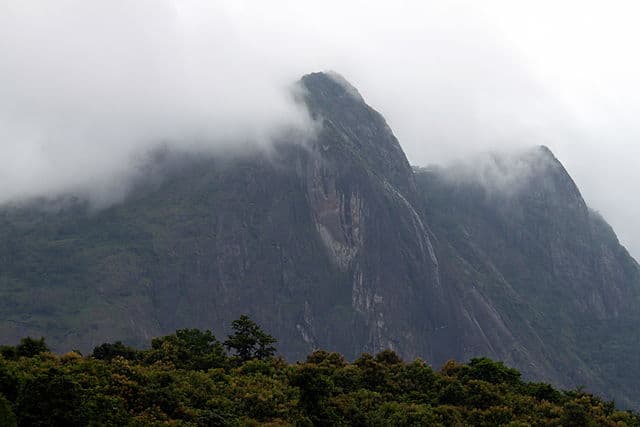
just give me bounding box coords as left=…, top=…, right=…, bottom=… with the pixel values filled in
left=0, top=73, right=640, bottom=407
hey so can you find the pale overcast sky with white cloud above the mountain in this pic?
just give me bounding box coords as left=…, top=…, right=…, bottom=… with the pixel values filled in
left=0, top=0, right=640, bottom=256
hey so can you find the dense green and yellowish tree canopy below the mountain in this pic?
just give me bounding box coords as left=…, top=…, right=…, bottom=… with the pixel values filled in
left=0, top=316, right=640, bottom=426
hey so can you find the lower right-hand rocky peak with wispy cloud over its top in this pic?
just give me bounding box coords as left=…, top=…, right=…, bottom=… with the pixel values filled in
left=416, top=147, right=640, bottom=406
